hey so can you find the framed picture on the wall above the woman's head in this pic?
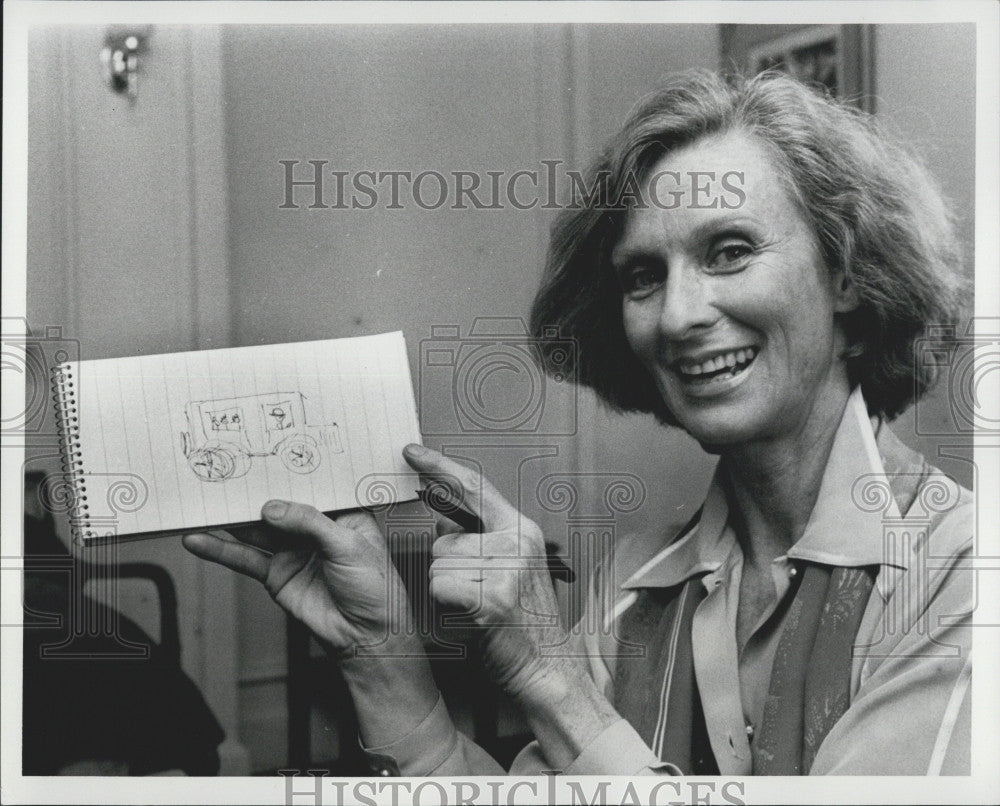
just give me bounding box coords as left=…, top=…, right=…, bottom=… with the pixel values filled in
left=721, top=25, right=875, bottom=112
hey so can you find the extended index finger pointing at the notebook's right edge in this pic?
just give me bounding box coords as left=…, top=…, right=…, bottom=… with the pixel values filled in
left=403, top=444, right=518, bottom=531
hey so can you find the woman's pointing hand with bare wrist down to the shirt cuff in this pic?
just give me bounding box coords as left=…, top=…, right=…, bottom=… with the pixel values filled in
left=404, top=445, right=621, bottom=770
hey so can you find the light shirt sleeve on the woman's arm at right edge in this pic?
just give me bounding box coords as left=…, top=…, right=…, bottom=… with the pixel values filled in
left=810, top=508, right=973, bottom=775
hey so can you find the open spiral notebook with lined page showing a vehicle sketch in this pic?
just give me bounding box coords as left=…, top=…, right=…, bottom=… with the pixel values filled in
left=53, top=332, right=420, bottom=542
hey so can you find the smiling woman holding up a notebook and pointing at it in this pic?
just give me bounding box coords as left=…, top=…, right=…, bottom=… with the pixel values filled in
left=185, top=73, right=972, bottom=775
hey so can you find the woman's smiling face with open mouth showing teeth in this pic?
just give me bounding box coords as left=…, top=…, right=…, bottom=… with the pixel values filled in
left=612, top=132, right=854, bottom=449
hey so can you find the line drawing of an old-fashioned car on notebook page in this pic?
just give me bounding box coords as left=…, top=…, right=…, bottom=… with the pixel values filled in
left=181, top=392, right=343, bottom=482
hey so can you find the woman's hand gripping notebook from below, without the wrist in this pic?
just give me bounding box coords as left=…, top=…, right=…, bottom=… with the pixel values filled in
left=183, top=501, right=410, bottom=659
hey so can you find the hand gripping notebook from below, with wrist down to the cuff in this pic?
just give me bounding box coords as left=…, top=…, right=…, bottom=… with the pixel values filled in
left=184, top=501, right=440, bottom=747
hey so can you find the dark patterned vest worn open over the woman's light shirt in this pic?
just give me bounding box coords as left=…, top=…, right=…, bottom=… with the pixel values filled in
left=614, top=424, right=929, bottom=775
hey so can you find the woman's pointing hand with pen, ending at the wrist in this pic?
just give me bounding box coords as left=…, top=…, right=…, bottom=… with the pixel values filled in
left=404, top=445, right=586, bottom=701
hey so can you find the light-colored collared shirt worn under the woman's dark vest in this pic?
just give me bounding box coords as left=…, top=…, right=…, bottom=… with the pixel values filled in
left=366, top=389, right=974, bottom=776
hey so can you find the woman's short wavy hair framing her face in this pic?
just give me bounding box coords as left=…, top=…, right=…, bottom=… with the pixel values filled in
left=531, top=71, right=968, bottom=425
